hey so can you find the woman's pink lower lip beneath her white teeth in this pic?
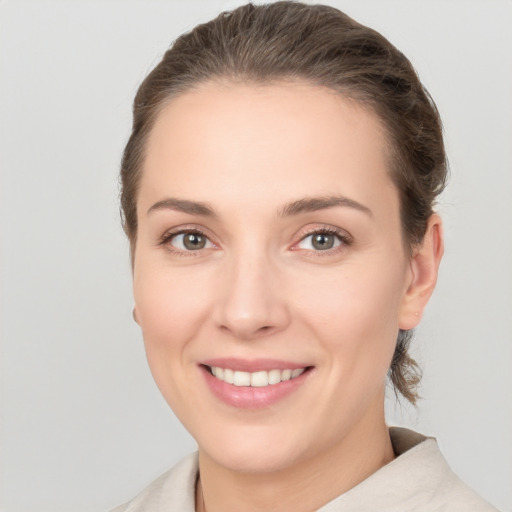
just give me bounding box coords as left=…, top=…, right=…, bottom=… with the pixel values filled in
left=200, top=366, right=310, bottom=409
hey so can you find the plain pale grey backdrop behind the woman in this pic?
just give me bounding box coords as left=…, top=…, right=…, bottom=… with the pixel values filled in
left=0, top=0, right=512, bottom=512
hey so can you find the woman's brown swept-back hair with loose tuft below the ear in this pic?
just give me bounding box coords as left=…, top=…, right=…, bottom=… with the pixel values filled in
left=121, top=1, right=447, bottom=403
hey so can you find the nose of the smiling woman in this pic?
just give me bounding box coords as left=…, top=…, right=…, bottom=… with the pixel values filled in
left=214, top=254, right=290, bottom=340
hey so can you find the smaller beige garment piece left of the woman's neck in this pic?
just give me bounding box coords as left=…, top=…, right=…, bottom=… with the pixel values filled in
left=111, top=453, right=198, bottom=512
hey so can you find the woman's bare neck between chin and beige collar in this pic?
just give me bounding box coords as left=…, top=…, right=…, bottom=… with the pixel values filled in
left=196, top=400, right=394, bottom=512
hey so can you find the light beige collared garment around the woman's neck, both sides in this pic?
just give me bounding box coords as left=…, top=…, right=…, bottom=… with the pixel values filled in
left=112, top=427, right=497, bottom=512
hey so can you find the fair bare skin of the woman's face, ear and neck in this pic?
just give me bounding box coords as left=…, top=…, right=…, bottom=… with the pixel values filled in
left=134, top=82, right=443, bottom=512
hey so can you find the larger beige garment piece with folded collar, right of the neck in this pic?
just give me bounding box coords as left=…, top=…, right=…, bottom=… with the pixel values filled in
left=320, top=428, right=497, bottom=512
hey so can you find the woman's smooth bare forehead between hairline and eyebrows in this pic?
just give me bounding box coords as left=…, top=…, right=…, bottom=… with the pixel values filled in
left=140, top=82, right=391, bottom=214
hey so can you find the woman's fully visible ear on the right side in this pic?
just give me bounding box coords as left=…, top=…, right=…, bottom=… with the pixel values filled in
left=399, top=213, right=444, bottom=330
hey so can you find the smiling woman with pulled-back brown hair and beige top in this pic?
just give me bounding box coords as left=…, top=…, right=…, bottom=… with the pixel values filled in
left=116, top=2, right=500, bottom=512
